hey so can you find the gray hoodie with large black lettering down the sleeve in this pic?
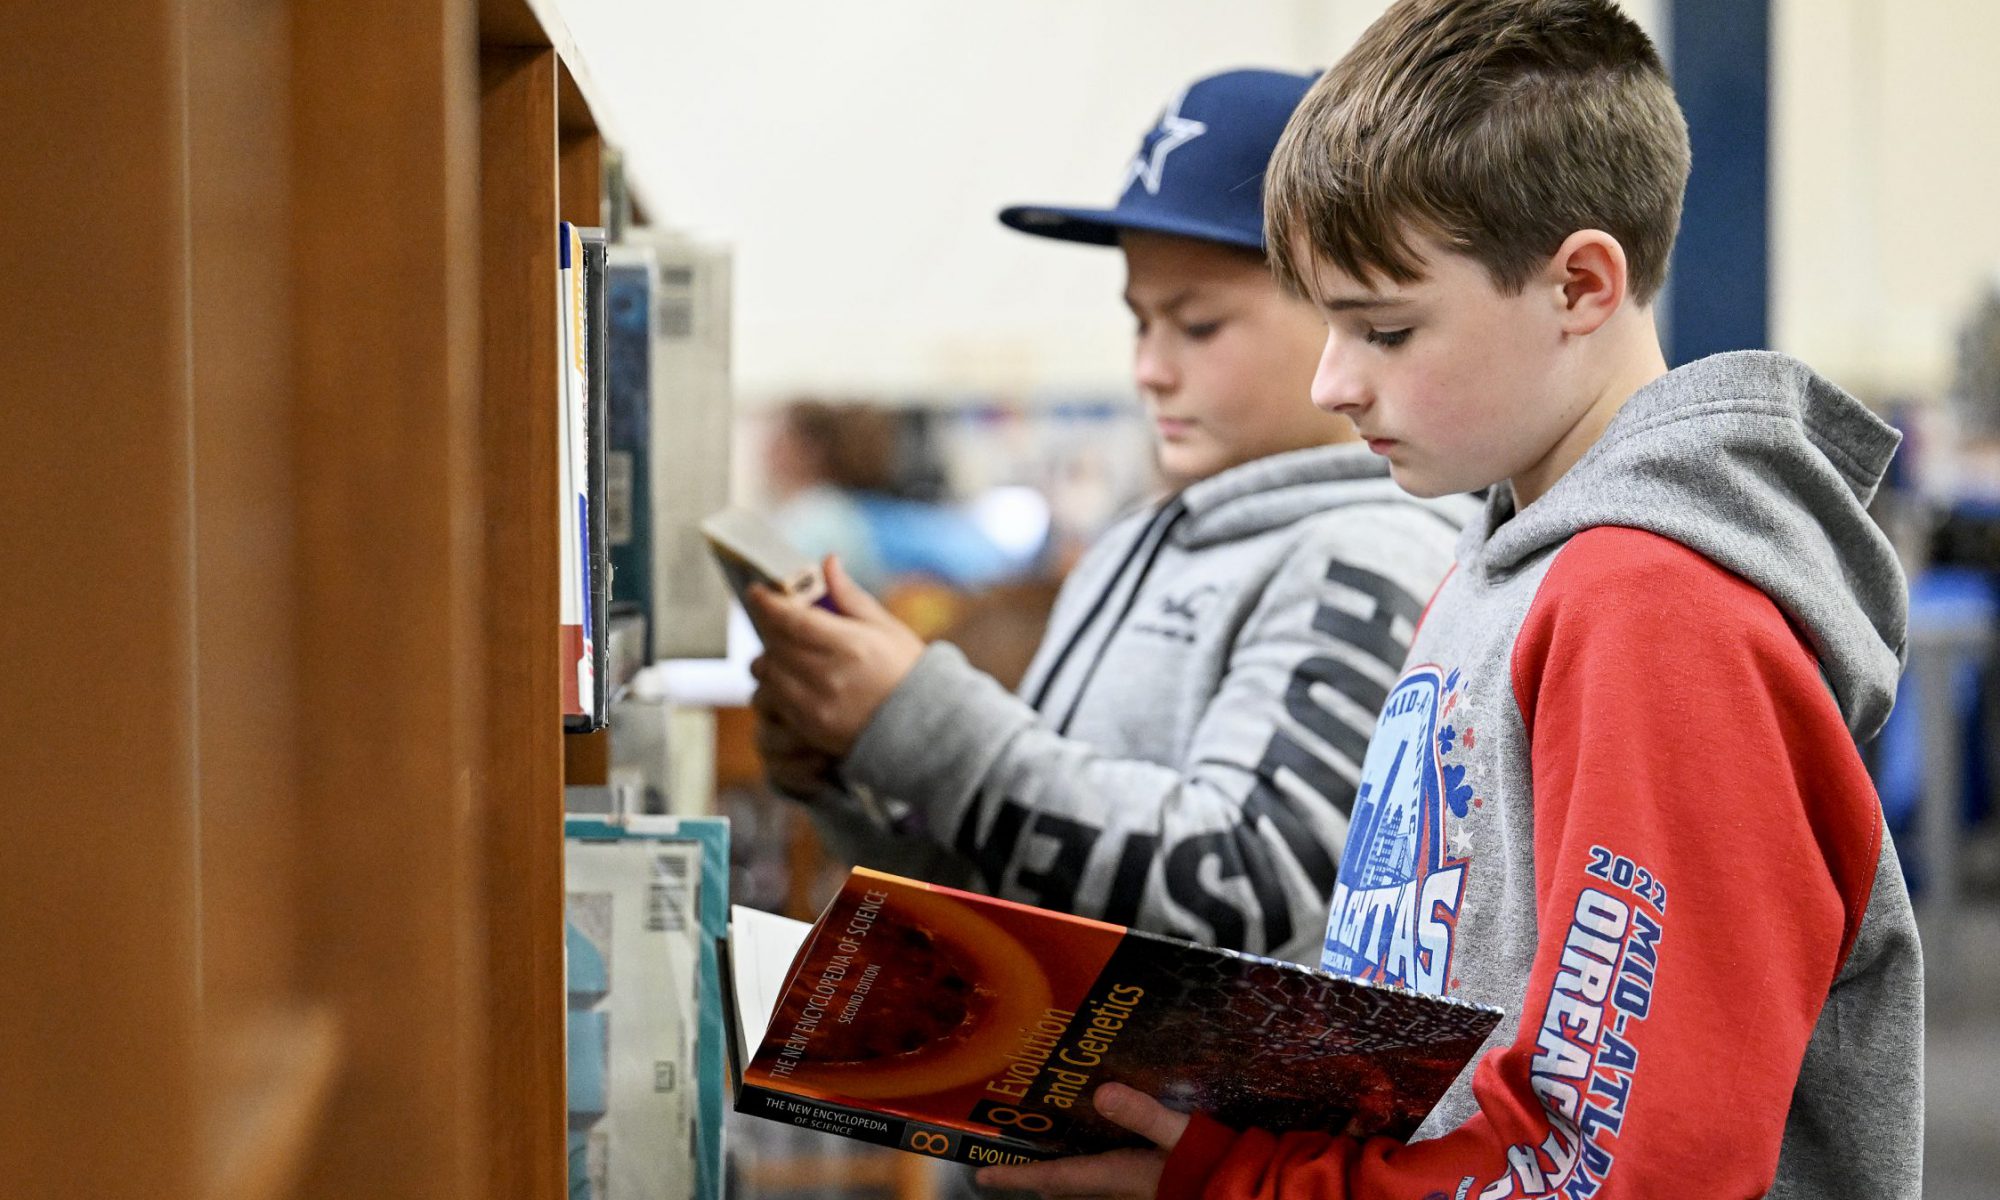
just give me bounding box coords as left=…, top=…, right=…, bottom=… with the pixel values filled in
left=814, top=446, right=1476, bottom=962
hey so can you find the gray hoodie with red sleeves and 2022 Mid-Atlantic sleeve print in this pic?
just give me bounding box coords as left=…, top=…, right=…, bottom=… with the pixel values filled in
left=1184, top=354, right=1924, bottom=1200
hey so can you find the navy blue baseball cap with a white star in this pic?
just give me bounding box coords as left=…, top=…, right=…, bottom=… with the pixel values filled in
left=1000, top=70, right=1318, bottom=250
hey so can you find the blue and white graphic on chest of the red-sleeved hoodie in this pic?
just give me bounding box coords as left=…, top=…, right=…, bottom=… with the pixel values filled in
left=1320, top=664, right=1476, bottom=996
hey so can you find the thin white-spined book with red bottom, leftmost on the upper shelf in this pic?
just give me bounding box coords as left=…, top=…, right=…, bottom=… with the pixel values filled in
left=556, top=222, right=598, bottom=732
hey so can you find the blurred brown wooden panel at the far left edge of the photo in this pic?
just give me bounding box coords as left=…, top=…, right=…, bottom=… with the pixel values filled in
left=0, top=0, right=198, bottom=1200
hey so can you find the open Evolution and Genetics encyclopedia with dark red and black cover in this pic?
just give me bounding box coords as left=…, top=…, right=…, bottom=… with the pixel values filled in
left=724, top=868, right=1502, bottom=1164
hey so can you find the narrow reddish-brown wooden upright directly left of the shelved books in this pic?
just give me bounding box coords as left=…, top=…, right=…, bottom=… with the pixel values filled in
left=480, top=48, right=568, bottom=1200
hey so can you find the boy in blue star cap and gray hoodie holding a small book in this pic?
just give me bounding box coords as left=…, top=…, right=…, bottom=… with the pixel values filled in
left=752, top=70, right=1474, bottom=962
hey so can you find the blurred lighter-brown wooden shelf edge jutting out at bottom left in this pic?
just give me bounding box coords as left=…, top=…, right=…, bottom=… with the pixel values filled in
left=204, top=1008, right=340, bottom=1200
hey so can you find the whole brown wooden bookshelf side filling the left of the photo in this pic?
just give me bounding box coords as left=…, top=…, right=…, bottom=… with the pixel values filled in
left=0, top=0, right=616, bottom=1200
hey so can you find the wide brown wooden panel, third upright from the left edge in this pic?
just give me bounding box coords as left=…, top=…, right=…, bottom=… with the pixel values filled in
left=292, top=0, right=488, bottom=1200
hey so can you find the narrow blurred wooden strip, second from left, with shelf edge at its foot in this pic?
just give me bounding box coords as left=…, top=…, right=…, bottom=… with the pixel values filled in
left=184, top=0, right=338, bottom=1200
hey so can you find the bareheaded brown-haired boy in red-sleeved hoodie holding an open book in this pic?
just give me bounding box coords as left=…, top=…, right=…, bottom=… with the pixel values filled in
left=990, top=0, right=1924, bottom=1200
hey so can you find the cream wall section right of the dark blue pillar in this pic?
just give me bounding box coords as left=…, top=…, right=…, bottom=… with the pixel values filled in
left=1772, top=0, right=2000, bottom=396
